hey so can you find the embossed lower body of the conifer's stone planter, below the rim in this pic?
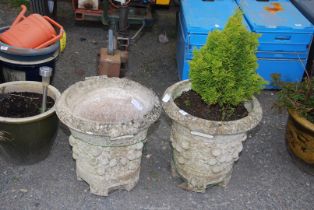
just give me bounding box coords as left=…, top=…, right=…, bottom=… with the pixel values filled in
left=171, top=123, right=246, bottom=192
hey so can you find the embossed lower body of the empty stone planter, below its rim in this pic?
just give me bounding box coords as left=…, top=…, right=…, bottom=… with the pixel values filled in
left=69, top=136, right=143, bottom=196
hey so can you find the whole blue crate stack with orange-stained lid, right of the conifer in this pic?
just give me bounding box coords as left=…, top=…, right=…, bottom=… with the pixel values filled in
left=237, top=0, right=314, bottom=89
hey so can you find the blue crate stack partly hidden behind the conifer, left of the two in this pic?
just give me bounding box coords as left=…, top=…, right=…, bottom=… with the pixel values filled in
left=177, top=0, right=238, bottom=80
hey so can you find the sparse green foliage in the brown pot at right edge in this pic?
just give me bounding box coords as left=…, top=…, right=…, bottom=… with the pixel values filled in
left=273, top=74, right=314, bottom=123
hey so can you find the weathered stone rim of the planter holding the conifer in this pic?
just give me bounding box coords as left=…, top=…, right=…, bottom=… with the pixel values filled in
left=162, top=80, right=263, bottom=135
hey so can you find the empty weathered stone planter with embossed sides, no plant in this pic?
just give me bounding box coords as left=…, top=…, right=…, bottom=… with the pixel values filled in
left=57, top=77, right=161, bottom=196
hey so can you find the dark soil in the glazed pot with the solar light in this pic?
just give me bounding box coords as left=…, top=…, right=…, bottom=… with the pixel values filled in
left=0, top=92, right=54, bottom=118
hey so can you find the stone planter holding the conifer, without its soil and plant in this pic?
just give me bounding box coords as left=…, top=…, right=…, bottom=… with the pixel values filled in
left=162, top=80, right=262, bottom=192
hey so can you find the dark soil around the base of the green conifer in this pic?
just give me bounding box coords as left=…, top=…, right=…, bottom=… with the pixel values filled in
left=174, top=90, right=248, bottom=121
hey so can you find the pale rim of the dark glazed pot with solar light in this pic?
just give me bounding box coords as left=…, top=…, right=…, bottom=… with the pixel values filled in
left=0, top=81, right=61, bottom=124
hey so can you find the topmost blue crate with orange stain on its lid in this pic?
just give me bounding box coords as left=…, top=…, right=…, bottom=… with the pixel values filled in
left=237, top=0, right=314, bottom=52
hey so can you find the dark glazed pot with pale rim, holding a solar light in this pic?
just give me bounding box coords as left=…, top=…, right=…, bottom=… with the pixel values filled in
left=0, top=81, right=60, bottom=164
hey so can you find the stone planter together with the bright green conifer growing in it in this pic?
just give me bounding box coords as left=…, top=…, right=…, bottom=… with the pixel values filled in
left=163, top=10, right=265, bottom=192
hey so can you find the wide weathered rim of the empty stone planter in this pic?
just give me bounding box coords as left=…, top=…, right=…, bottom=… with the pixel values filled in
left=56, top=76, right=161, bottom=137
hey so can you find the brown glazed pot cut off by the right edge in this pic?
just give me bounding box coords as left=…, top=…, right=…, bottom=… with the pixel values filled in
left=286, top=110, right=314, bottom=175
